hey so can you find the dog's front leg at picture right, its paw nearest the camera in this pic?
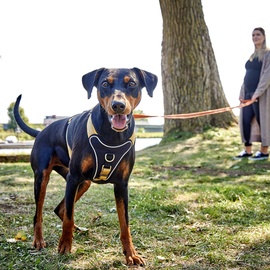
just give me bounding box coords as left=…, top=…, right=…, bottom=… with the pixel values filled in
left=114, top=183, right=145, bottom=266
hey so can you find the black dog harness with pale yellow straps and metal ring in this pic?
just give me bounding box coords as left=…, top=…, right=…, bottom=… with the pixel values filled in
left=66, top=113, right=136, bottom=181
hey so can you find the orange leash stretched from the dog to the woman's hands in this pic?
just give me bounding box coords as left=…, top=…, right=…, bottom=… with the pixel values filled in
left=133, top=100, right=254, bottom=119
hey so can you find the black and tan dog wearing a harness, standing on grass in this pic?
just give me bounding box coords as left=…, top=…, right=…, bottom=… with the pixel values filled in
left=14, top=68, right=157, bottom=265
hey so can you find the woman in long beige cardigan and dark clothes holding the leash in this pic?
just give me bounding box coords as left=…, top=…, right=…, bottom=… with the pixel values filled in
left=234, top=27, right=270, bottom=160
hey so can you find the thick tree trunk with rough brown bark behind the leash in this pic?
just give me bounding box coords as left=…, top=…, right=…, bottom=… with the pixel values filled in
left=160, top=0, right=236, bottom=136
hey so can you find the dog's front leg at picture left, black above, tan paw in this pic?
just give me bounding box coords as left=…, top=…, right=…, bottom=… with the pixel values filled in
left=58, top=175, right=78, bottom=254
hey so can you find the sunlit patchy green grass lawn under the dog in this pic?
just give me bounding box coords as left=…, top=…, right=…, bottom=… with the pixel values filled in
left=0, top=124, right=270, bottom=270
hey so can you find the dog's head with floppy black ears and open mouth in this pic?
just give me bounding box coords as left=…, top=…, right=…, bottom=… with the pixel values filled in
left=82, top=68, right=158, bottom=132
